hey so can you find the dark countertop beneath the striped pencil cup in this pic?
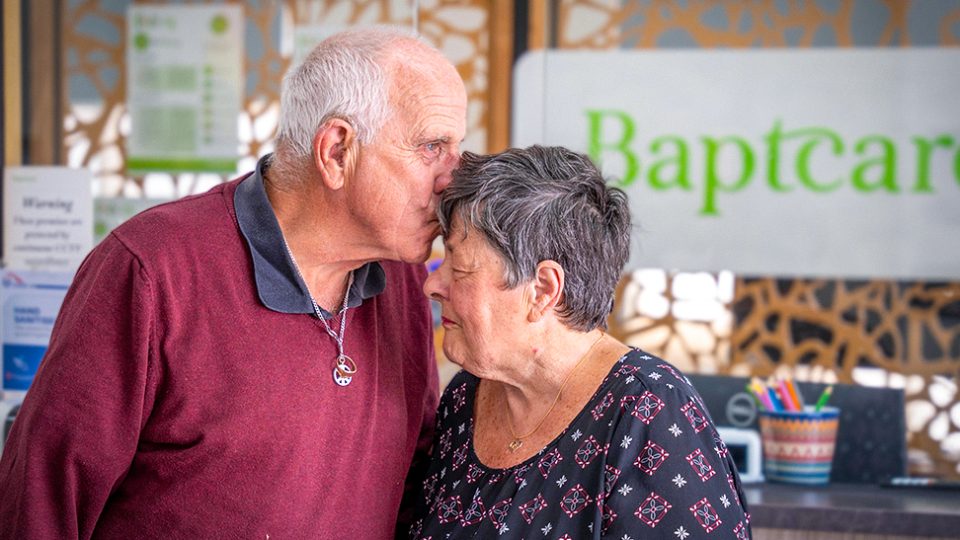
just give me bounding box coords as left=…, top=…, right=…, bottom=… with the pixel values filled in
left=744, top=483, right=960, bottom=538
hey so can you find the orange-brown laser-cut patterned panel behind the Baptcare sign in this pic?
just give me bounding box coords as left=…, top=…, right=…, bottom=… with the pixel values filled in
left=552, top=0, right=960, bottom=477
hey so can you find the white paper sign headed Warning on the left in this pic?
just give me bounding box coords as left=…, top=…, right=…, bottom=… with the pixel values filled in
left=3, top=167, right=93, bottom=273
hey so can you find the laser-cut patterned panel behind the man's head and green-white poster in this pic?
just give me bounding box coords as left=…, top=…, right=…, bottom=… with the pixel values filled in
left=62, top=0, right=490, bottom=198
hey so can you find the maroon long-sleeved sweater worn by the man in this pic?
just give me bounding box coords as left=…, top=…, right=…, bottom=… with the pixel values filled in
left=0, top=168, right=438, bottom=540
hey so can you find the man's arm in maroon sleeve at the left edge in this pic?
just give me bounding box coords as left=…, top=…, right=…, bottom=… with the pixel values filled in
left=0, top=236, right=156, bottom=540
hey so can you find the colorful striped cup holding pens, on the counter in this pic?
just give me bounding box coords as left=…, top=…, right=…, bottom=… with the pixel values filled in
left=760, top=407, right=840, bottom=484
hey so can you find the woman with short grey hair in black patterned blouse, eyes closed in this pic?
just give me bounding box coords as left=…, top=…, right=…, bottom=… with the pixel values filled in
left=411, top=146, right=750, bottom=540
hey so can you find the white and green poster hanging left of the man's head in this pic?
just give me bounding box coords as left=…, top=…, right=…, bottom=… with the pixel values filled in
left=127, top=5, right=244, bottom=174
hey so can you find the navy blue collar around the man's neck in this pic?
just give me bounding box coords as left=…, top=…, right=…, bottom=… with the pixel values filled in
left=233, top=154, right=387, bottom=319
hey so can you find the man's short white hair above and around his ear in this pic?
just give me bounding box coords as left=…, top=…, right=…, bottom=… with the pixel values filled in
left=277, top=27, right=417, bottom=158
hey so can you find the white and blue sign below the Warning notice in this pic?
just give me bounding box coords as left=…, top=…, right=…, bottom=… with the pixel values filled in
left=0, top=271, right=73, bottom=397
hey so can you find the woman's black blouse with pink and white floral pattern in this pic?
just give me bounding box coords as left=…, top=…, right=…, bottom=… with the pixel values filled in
left=411, top=350, right=750, bottom=540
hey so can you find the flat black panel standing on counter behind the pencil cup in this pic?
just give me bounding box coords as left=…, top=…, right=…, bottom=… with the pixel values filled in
left=688, top=375, right=907, bottom=484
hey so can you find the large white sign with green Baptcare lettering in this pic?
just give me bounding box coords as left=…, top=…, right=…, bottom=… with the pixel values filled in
left=512, top=48, right=960, bottom=279
